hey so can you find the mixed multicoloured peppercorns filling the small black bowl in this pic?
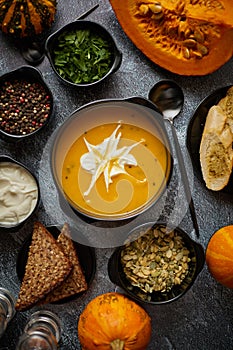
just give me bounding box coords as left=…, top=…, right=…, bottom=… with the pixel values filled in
left=0, top=80, right=52, bottom=135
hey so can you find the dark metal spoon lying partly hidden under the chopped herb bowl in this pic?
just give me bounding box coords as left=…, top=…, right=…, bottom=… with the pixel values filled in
left=21, top=4, right=99, bottom=65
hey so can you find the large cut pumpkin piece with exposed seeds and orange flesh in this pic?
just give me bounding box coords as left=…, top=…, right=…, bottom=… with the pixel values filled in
left=110, top=0, right=233, bottom=76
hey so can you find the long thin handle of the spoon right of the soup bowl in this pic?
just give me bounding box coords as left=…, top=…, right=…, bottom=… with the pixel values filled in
left=169, top=120, right=200, bottom=237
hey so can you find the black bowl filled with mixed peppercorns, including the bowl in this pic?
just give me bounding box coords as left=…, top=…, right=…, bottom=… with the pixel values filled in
left=0, top=66, right=53, bottom=141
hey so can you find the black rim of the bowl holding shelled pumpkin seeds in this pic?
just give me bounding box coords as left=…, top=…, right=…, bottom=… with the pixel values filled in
left=108, top=221, right=205, bottom=305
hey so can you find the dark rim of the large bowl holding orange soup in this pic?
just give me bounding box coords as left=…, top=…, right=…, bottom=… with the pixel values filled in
left=50, top=96, right=174, bottom=222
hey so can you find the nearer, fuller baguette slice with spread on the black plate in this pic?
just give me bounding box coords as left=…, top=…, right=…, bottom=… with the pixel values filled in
left=200, top=104, right=233, bottom=191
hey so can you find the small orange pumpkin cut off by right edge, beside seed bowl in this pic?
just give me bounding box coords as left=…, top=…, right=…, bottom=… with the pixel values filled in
left=206, top=225, right=233, bottom=288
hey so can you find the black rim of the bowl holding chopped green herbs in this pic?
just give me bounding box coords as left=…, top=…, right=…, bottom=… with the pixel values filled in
left=45, top=19, right=122, bottom=87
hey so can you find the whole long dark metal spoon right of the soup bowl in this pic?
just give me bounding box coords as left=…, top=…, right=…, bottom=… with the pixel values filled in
left=149, top=80, right=199, bottom=237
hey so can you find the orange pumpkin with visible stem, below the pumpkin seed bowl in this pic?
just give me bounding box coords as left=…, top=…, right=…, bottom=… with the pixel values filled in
left=78, top=292, right=151, bottom=350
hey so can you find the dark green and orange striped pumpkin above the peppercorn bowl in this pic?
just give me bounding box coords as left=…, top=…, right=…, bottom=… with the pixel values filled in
left=0, top=0, right=57, bottom=38
